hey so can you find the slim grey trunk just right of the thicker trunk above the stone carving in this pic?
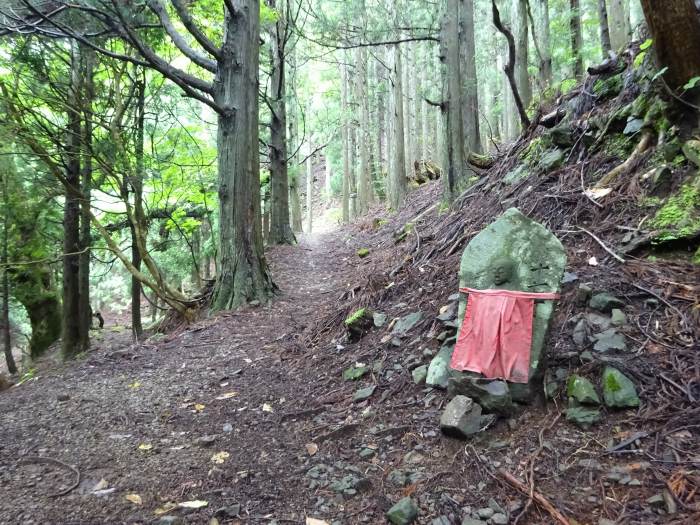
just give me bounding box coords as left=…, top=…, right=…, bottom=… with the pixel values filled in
left=459, top=0, right=482, bottom=153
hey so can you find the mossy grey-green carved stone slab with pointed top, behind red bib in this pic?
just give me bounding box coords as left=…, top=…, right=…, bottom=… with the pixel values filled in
left=457, top=208, right=566, bottom=401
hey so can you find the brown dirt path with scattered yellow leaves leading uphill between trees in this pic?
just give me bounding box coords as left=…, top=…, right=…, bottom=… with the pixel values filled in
left=0, top=233, right=378, bottom=525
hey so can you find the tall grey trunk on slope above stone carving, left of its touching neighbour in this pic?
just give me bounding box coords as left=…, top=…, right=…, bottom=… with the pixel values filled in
left=440, top=0, right=465, bottom=202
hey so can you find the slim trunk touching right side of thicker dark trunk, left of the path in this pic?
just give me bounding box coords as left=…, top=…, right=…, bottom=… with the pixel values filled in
left=79, top=45, right=95, bottom=351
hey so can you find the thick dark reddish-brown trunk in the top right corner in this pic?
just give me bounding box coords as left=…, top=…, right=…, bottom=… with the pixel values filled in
left=642, top=0, right=700, bottom=89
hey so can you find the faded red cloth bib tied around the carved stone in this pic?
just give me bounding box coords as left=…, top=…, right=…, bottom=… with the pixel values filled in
left=450, top=288, right=559, bottom=383
